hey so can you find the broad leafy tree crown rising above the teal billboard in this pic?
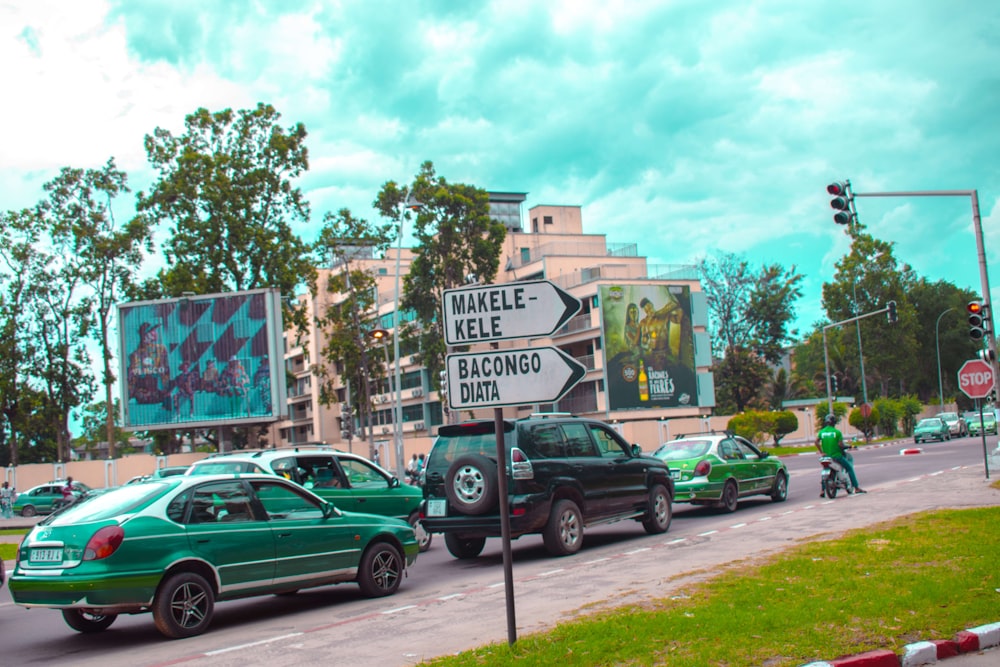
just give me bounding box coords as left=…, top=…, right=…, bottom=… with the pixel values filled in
left=137, top=104, right=315, bottom=295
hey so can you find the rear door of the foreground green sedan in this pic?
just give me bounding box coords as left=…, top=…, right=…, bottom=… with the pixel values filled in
left=180, top=479, right=275, bottom=597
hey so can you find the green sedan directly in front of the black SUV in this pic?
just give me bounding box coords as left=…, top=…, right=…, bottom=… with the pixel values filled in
left=653, top=433, right=788, bottom=512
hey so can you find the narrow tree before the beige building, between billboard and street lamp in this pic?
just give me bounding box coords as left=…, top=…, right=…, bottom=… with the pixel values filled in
left=313, top=209, right=392, bottom=458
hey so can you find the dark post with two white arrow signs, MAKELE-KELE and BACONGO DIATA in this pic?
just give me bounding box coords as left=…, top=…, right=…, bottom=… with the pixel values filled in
left=442, top=280, right=587, bottom=644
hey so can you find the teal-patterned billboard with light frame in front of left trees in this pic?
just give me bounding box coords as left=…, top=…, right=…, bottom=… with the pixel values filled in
left=118, top=289, right=287, bottom=430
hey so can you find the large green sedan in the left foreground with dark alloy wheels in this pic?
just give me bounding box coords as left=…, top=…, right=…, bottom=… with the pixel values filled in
left=8, top=475, right=419, bottom=638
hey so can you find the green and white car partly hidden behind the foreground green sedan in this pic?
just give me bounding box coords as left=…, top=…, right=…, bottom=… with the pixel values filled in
left=187, top=445, right=431, bottom=551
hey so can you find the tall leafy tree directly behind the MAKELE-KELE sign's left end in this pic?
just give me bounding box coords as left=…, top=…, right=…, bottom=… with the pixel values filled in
left=374, top=161, right=507, bottom=404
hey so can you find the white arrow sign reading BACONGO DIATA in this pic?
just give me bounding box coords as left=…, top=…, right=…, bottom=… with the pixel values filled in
left=445, top=347, right=587, bottom=410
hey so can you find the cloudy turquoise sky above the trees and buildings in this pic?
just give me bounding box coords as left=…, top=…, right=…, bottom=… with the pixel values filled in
left=0, top=0, right=1000, bottom=333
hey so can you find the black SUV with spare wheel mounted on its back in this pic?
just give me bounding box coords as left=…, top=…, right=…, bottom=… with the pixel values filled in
left=423, top=415, right=674, bottom=558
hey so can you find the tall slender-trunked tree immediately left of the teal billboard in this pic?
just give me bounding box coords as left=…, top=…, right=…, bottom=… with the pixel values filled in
left=43, top=159, right=152, bottom=458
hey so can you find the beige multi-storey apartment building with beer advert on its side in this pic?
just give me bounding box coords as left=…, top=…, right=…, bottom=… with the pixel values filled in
left=276, top=192, right=715, bottom=469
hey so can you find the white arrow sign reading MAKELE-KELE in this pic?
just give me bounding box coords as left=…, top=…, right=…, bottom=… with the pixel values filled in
left=444, top=280, right=580, bottom=348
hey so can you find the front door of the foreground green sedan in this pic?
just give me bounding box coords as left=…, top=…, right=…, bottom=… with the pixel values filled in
left=250, top=479, right=362, bottom=589
